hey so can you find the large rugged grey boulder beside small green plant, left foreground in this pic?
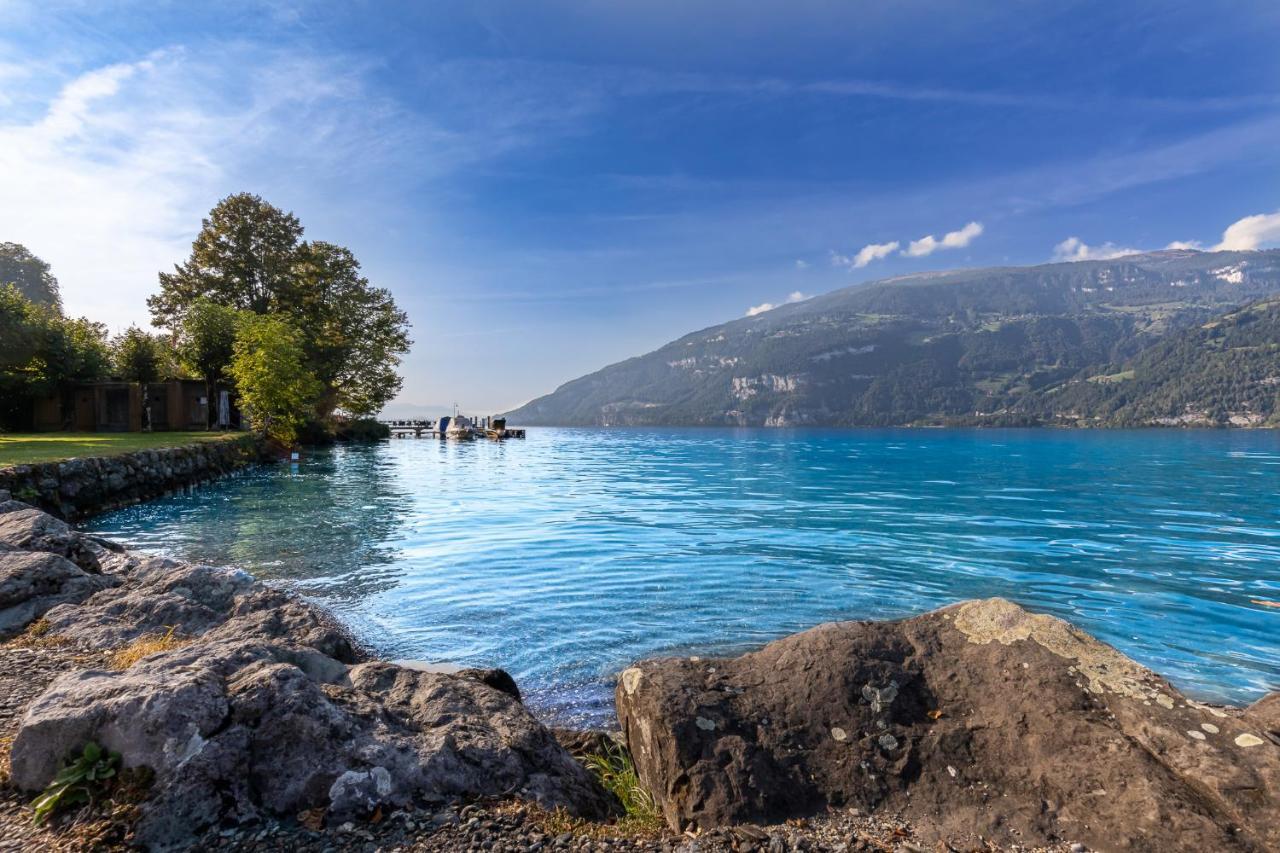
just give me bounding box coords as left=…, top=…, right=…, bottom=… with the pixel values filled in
left=10, top=638, right=611, bottom=849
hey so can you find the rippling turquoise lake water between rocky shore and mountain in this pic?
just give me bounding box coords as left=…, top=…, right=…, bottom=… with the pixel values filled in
left=86, top=429, right=1280, bottom=722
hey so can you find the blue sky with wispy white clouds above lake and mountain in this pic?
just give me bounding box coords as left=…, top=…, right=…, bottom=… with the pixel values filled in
left=0, top=0, right=1280, bottom=415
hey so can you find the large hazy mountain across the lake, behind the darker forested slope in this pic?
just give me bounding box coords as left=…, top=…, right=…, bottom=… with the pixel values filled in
left=509, top=250, right=1280, bottom=427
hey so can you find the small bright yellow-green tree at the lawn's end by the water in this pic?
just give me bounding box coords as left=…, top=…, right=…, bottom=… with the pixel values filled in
left=228, top=314, right=320, bottom=444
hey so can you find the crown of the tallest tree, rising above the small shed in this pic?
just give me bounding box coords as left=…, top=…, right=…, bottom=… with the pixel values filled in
left=147, top=192, right=302, bottom=329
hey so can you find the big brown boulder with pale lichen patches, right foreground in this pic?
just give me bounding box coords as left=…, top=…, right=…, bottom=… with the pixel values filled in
left=617, top=598, right=1280, bottom=850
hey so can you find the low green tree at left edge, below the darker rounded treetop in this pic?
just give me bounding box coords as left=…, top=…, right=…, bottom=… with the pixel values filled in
left=0, top=284, right=111, bottom=429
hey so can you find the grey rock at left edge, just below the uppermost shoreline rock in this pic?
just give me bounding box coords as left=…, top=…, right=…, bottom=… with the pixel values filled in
left=0, top=551, right=116, bottom=640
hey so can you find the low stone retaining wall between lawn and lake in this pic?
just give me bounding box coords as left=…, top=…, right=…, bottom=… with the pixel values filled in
left=0, top=435, right=262, bottom=521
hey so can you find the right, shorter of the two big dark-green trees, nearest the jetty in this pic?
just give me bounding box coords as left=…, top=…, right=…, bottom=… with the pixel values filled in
left=289, top=241, right=411, bottom=418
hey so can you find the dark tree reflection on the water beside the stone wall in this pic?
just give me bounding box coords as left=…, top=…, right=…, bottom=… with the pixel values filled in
left=222, top=446, right=412, bottom=601
